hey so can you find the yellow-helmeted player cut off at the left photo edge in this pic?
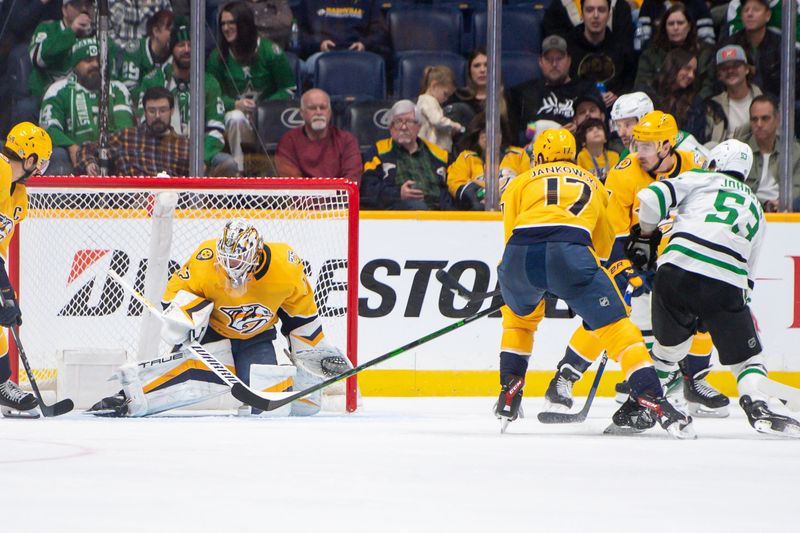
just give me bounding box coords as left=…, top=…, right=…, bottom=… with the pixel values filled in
left=0, top=122, right=53, bottom=417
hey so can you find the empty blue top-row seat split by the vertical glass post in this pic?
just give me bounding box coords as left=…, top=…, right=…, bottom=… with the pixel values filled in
left=472, top=4, right=542, bottom=54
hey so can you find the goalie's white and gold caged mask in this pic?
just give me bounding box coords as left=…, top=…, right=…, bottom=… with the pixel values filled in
left=217, top=220, right=263, bottom=288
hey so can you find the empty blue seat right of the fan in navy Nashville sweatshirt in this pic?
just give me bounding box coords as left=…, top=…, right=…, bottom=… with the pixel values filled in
left=388, top=5, right=463, bottom=54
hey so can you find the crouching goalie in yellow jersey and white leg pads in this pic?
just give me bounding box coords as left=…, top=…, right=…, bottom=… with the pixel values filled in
left=89, top=220, right=352, bottom=417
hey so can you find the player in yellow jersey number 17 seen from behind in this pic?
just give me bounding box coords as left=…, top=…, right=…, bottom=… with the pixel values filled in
left=495, top=129, right=693, bottom=437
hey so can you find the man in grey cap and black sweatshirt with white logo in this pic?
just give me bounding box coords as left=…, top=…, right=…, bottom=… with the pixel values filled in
left=509, top=35, right=605, bottom=144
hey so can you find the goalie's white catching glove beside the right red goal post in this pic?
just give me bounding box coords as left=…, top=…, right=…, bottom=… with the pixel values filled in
left=286, top=319, right=353, bottom=378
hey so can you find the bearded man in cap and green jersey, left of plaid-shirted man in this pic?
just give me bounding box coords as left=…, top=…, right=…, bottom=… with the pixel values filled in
left=39, top=37, right=134, bottom=175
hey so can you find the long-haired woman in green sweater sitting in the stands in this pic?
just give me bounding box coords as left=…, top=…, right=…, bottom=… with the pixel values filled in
left=206, top=1, right=296, bottom=171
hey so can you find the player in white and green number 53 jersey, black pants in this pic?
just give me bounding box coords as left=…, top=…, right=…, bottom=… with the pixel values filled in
left=626, top=140, right=800, bottom=437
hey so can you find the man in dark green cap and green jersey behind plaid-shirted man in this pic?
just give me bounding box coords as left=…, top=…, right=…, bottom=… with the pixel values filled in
left=138, top=17, right=239, bottom=176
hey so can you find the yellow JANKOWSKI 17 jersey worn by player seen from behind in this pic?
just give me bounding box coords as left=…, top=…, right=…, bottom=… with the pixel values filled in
left=501, top=162, right=614, bottom=259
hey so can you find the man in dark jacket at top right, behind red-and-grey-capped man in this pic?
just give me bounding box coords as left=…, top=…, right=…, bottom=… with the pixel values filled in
left=725, top=0, right=781, bottom=97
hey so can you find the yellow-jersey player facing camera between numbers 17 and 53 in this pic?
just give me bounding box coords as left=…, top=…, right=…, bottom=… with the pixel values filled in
left=544, top=111, right=729, bottom=416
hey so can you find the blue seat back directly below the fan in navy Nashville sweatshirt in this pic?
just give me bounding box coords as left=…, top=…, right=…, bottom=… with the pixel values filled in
left=314, top=52, right=386, bottom=100
